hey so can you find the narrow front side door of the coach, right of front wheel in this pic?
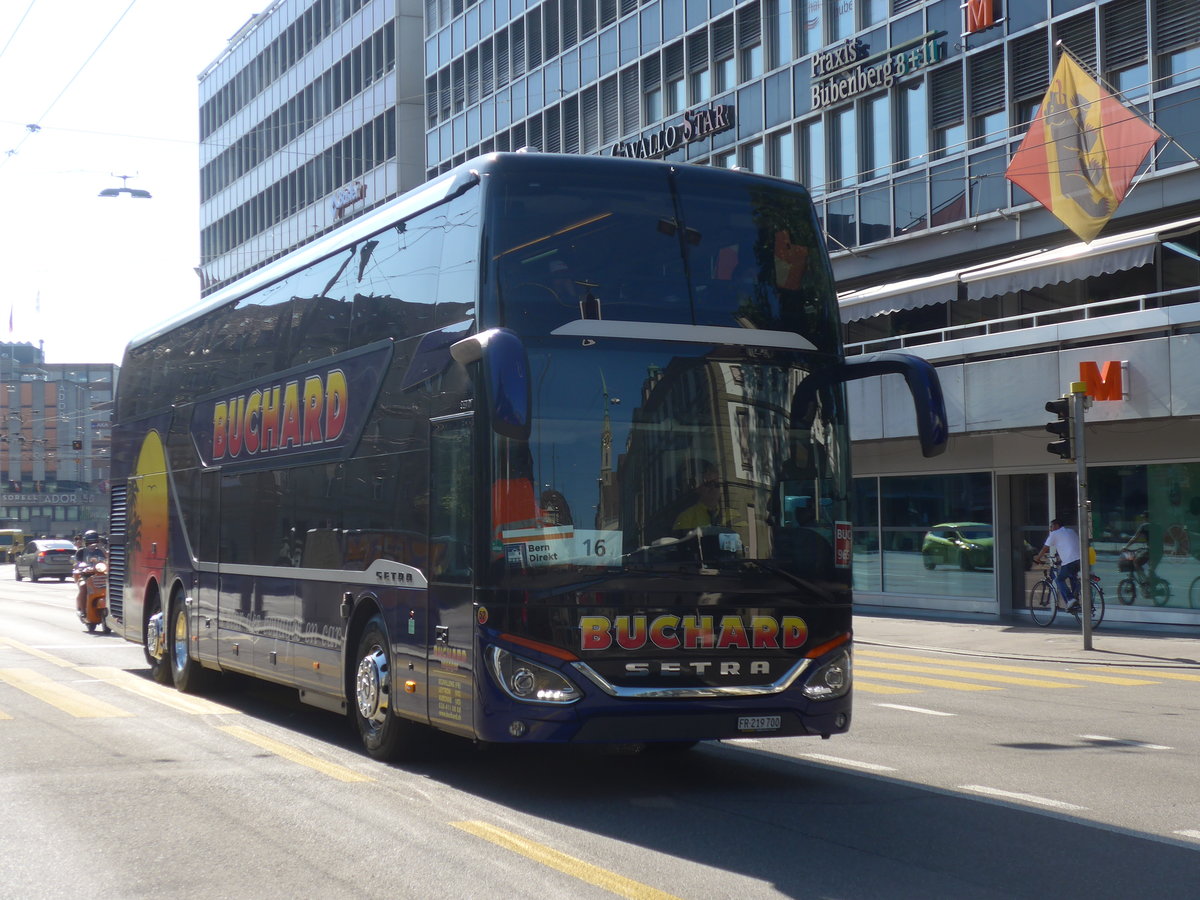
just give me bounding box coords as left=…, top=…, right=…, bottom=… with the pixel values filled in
left=427, top=413, right=479, bottom=736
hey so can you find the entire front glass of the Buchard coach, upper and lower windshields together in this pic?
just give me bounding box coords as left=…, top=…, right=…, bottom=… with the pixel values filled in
left=484, top=167, right=848, bottom=590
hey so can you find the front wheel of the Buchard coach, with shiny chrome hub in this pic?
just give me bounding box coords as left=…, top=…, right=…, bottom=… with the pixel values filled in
left=350, top=616, right=425, bottom=761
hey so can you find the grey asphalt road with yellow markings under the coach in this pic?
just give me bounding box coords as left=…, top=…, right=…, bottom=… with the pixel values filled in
left=0, top=566, right=1200, bottom=900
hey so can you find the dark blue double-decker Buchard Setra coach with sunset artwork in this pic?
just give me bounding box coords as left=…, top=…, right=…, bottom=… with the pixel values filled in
left=109, top=152, right=946, bottom=758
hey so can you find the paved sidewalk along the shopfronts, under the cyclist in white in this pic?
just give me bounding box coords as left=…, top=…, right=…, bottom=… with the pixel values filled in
left=854, top=611, right=1200, bottom=670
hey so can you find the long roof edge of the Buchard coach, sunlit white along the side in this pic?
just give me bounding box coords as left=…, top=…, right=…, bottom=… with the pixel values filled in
left=126, top=151, right=805, bottom=352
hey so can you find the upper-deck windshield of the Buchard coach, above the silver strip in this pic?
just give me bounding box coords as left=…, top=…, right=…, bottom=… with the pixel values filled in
left=488, top=163, right=840, bottom=353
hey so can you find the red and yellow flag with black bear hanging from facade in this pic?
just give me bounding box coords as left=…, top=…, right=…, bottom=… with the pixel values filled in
left=1004, top=54, right=1162, bottom=244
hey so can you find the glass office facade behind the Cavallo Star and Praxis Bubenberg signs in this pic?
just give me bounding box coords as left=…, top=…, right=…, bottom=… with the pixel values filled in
left=426, top=0, right=1200, bottom=251
